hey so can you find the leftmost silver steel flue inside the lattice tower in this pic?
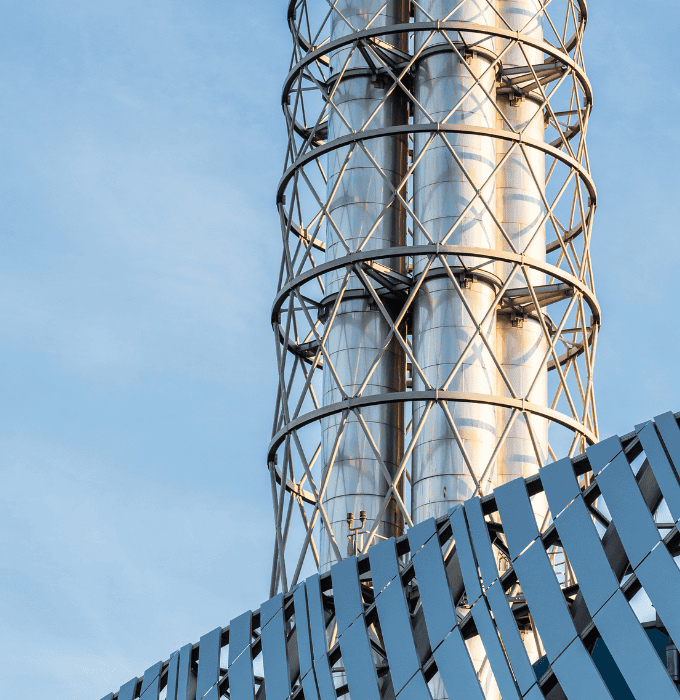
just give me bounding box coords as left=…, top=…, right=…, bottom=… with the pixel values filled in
left=319, top=0, right=408, bottom=571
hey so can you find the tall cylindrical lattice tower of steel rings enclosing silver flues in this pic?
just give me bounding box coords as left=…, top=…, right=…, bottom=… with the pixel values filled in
left=268, top=0, right=600, bottom=594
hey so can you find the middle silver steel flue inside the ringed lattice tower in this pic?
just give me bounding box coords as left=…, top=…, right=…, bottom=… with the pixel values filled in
left=411, top=0, right=497, bottom=523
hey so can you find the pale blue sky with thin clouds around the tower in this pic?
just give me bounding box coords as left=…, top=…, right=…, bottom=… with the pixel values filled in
left=0, top=0, right=680, bottom=700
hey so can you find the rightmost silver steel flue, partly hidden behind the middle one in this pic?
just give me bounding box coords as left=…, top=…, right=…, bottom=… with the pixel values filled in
left=496, top=0, right=548, bottom=498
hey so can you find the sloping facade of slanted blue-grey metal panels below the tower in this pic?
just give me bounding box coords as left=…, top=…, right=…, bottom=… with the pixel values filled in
left=98, top=413, right=680, bottom=700
